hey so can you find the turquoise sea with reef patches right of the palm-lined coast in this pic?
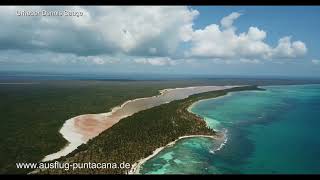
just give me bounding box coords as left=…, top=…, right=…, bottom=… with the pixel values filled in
left=140, top=85, right=320, bottom=174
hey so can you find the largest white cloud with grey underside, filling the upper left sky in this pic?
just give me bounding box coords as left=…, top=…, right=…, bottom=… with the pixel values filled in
left=0, top=6, right=199, bottom=56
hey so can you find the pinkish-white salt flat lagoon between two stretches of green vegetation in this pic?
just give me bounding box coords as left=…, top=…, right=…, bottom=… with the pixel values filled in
left=42, top=86, right=238, bottom=161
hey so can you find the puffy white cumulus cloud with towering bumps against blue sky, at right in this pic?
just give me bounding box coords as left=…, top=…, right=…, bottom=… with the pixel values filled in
left=186, top=13, right=307, bottom=59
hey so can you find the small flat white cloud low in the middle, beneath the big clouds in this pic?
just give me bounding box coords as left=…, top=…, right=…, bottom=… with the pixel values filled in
left=134, top=57, right=176, bottom=66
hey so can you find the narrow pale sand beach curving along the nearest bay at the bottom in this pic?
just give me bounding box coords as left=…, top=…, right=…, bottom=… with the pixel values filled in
left=128, top=135, right=219, bottom=174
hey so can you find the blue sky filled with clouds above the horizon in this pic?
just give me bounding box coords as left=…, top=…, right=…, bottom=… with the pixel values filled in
left=0, top=6, right=320, bottom=77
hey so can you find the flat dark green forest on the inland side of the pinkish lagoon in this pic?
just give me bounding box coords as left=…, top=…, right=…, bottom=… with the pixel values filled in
left=0, top=81, right=204, bottom=174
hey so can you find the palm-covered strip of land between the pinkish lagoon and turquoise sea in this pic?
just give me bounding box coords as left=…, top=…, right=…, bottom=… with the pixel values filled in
left=41, top=86, right=261, bottom=174
